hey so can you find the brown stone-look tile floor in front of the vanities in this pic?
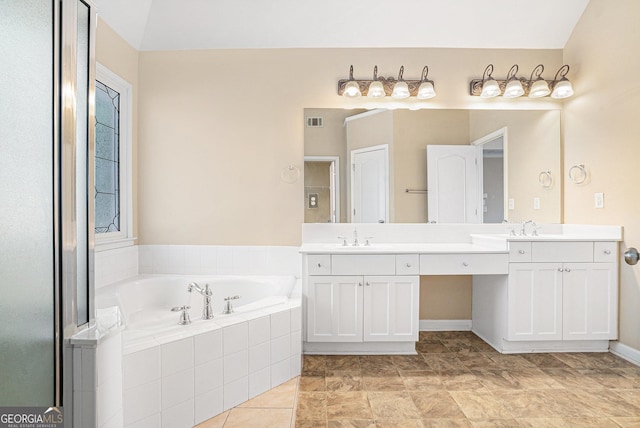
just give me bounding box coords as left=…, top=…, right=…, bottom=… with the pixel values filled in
left=296, top=332, right=640, bottom=428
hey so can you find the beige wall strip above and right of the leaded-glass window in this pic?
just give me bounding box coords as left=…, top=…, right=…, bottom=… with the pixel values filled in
left=96, top=19, right=138, bottom=241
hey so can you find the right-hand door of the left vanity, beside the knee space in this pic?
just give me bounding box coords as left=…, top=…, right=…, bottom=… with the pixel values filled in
left=363, top=276, right=420, bottom=342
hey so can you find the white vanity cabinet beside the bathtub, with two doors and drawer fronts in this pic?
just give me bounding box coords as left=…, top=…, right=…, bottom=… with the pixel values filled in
left=305, top=254, right=420, bottom=353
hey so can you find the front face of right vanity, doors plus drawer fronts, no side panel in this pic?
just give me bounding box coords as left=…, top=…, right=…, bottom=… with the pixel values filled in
left=507, top=241, right=618, bottom=340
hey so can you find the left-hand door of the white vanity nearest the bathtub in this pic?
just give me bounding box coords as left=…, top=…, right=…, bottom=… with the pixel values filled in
left=307, top=276, right=363, bottom=342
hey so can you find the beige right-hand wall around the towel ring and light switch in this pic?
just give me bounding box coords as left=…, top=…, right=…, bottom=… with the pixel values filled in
left=563, top=0, right=640, bottom=349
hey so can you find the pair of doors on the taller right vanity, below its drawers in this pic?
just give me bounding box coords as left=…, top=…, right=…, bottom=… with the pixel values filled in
left=507, top=263, right=618, bottom=340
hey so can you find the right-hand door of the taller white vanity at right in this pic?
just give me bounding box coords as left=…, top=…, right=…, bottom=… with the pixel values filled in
left=562, top=263, right=618, bottom=340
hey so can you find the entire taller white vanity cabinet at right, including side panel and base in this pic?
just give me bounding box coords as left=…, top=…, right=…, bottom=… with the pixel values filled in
left=472, top=239, right=618, bottom=352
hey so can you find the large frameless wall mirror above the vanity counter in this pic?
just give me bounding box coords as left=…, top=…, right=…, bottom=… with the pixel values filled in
left=304, top=108, right=561, bottom=223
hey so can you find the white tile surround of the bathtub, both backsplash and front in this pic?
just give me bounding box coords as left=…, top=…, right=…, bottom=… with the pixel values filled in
left=85, top=245, right=302, bottom=428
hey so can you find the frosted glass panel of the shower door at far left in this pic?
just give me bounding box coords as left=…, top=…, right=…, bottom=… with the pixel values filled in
left=0, top=0, right=57, bottom=406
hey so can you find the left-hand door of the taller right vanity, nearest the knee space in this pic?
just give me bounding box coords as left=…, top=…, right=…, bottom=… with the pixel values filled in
left=507, top=263, right=562, bottom=340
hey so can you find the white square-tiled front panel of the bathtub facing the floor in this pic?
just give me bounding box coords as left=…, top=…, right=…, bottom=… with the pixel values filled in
left=123, top=301, right=302, bottom=428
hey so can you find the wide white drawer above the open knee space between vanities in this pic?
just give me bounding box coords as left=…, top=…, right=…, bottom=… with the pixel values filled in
left=420, top=254, right=509, bottom=275
